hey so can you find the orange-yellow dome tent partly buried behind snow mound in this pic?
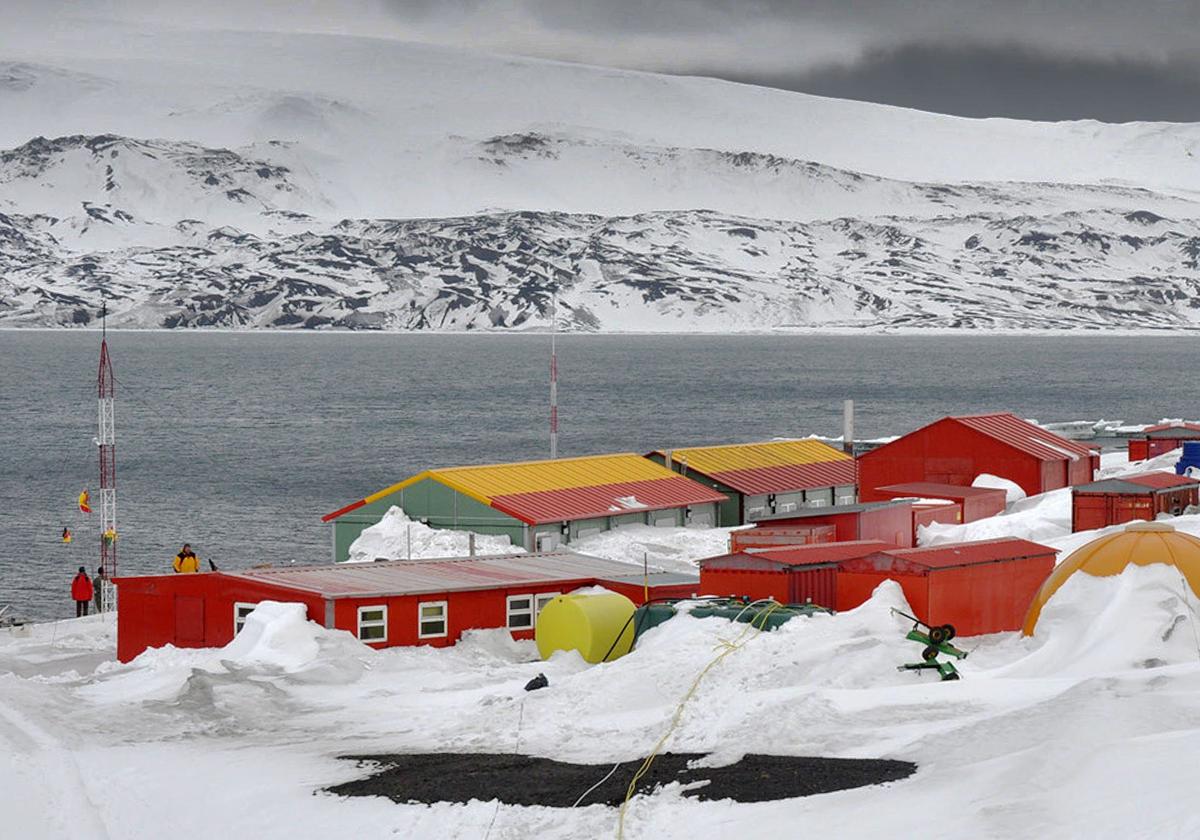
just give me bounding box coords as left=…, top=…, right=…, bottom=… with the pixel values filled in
left=1021, top=522, right=1200, bottom=636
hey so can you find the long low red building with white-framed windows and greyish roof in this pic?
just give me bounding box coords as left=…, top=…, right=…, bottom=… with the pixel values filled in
left=115, top=552, right=698, bottom=662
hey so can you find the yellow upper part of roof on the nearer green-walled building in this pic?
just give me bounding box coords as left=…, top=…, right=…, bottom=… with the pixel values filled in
left=365, top=452, right=677, bottom=504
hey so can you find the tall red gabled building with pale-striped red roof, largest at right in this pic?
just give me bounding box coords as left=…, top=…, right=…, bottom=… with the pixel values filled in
left=858, top=413, right=1100, bottom=502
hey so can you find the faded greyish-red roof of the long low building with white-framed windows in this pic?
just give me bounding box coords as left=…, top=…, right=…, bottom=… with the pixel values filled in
left=217, top=552, right=654, bottom=599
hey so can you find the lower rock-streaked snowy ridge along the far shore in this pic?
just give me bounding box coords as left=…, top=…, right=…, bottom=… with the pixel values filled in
left=0, top=181, right=1200, bottom=331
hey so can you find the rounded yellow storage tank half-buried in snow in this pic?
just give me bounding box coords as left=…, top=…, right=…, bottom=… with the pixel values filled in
left=534, top=593, right=637, bottom=664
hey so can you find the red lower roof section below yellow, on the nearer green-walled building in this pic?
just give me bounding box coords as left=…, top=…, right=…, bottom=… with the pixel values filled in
left=492, top=475, right=725, bottom=524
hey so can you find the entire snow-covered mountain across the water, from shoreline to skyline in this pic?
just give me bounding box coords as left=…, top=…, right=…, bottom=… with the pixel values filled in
left=0, top=32, right=1200, bottom=331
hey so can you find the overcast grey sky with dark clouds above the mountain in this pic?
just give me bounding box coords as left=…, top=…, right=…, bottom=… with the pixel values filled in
left=9, top=0, right=1200, bottom=121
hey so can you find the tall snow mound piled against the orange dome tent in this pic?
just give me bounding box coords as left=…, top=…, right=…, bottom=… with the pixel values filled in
left=990, top=564, right=1200, bottom=678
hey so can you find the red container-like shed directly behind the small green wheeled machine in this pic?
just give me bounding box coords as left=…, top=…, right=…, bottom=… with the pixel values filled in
left=836, top=539, right=1055, bottom=636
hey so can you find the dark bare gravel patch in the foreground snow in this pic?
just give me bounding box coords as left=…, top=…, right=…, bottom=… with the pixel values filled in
left=328, top=752, right=917, bottom=808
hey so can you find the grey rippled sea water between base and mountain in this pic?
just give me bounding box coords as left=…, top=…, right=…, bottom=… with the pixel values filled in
left=0, top=331, right=1200, bottom=619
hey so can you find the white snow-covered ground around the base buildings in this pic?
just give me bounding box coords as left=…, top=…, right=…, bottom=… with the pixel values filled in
left=7, top=454, right=1200, bottom=840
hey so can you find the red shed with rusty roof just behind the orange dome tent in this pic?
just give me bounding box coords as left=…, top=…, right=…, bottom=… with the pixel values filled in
left=1070, top=473, right=1200, bottom=530
